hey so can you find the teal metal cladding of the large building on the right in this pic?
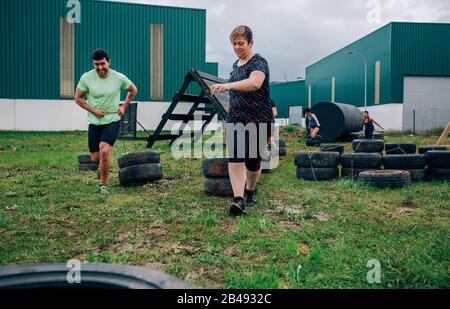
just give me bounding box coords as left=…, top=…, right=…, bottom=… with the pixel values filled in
left=306, top=22, right=450, bottom=107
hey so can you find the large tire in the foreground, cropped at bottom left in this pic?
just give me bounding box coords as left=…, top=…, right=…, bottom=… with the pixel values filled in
left=0, top=263, right=192, bottom=289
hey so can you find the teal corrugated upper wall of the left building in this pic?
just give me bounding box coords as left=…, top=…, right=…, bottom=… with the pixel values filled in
left=0, top=0, right=217, bottom=101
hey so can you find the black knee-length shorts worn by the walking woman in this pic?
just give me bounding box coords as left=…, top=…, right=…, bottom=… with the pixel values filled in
left=226, top=117, right=274, bottom=172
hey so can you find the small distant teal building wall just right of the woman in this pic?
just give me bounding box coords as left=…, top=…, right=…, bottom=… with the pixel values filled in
left=270, top=80, right=308, bottom=118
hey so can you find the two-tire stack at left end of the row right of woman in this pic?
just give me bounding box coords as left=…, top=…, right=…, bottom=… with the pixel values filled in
left=294, top=152, right=339, bottom=181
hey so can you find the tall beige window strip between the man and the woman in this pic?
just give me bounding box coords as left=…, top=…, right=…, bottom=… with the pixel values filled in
left=150, top=24, right=164, bottom=101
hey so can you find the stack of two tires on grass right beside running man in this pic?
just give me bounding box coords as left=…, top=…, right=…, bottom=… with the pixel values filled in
left=118, top=151, right=163, bottom=186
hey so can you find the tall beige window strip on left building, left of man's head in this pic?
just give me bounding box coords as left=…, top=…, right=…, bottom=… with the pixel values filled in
left=59, top=17, right=75, bottom=98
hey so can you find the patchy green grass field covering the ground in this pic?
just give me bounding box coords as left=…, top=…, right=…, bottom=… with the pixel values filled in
left=0, top=127, right=450, bottom=288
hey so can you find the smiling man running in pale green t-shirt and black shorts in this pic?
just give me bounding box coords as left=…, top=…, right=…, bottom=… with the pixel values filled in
left=75, top=49, right=137, bottom=194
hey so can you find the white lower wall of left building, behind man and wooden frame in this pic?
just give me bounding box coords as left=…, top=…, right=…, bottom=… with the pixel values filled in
left=0, top=99, right=217, bottom=131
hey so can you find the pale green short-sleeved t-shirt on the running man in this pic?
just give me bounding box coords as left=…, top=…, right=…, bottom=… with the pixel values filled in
left=78, top=69, right=131, bottom=125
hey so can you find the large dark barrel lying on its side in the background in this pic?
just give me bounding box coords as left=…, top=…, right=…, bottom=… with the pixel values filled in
left=311, top=102, right=364, bottom=142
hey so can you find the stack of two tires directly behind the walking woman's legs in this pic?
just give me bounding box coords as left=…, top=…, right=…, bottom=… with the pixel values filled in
left=202, top=158, right=233, bottom=197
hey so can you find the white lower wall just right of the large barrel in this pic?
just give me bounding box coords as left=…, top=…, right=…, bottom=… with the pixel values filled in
left=360, top=103, right=403, bottom=131
